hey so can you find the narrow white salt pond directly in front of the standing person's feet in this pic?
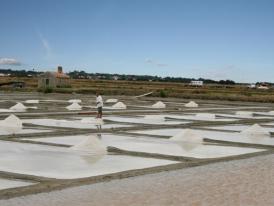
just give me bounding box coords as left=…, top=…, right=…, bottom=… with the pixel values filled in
left=22, top=119, right=132, bottom=129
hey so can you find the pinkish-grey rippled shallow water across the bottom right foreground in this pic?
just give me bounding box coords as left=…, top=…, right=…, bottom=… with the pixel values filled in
left=0, top=155, right=274, bottom=206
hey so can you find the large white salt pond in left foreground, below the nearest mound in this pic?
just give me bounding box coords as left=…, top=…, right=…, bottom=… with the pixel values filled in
left=0, top=141, right=177, bottom=179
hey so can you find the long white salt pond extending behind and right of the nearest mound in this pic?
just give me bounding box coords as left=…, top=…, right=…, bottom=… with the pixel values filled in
left=23, top=134, right=263, bottom=158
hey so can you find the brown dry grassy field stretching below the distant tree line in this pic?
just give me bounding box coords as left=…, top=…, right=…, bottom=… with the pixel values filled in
left=0, top=77, right=274, bottom=103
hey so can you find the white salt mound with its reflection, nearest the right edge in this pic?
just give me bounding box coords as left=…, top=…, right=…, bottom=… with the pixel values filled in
left=240, top=124, right=271, bottom=141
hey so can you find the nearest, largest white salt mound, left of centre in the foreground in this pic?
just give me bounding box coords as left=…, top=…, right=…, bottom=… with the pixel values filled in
left=70, top=136, right=107, bottom=155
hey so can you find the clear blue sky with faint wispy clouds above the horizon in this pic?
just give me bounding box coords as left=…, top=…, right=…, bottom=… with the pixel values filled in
left=0, top=0, right=274, bottom=82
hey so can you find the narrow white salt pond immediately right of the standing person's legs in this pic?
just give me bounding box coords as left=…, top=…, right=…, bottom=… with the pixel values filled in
left=104, top=115, right=189, bottom=125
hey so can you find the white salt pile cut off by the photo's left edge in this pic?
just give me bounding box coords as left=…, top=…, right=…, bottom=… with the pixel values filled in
left=0, top=114, right=23, bottom=134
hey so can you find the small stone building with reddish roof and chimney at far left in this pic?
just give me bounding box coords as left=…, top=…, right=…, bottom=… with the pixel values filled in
left=38, top=66, right=70, bottom=88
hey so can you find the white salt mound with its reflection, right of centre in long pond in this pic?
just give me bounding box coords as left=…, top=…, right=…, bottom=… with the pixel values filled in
left=170, top=129, right=203, bottom=151
